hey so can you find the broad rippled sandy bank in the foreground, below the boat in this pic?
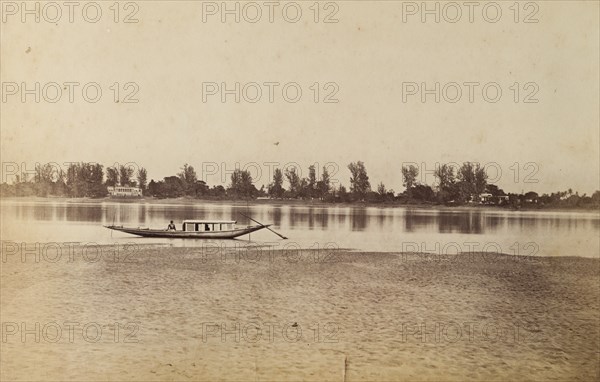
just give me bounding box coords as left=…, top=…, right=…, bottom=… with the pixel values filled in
left=1, top=246, right=600, bottom=381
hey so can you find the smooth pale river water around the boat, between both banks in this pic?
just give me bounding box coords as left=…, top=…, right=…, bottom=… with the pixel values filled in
left=1, top=200, right=600, bottom=257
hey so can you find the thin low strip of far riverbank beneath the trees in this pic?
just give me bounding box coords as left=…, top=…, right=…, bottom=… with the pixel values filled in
left=0, top=196, right=600, bottom=213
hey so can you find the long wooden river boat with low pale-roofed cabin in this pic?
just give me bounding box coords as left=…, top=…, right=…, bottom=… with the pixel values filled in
left=104, top=220, right=271, bottom=239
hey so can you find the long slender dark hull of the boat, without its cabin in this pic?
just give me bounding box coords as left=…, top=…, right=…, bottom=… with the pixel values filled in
left=104, top=224, right=270, bottom=239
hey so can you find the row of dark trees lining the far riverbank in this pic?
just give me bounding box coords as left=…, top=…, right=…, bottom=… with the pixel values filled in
left=0, top=161, right=600, bottom=208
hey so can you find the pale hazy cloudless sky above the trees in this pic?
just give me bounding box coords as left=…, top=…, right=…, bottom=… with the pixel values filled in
left=0, top=1, right=600, bottom=194
